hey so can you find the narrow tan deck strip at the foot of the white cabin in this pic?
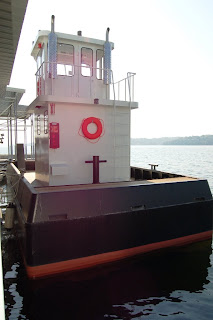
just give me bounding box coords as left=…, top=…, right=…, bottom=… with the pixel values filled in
left=24, top=171, right=198, bottom=192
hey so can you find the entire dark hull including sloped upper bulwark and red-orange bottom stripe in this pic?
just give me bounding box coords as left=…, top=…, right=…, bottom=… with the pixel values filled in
left=7, top=164, right=213, bottom=278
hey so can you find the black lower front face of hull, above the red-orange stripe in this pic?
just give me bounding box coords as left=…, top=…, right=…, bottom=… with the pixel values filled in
left=25, top=201, right=212, bottom=266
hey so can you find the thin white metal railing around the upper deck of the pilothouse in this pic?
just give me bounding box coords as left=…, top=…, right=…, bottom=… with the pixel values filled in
left=36, top=62, right=136, bottom=102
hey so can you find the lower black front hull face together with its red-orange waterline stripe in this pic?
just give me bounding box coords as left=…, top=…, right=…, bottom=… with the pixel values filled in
left=26, top=203, right=212, bottom=277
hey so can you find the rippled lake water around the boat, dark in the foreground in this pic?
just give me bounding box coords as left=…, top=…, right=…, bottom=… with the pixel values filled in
left=2, top=146, right=213, bottom=320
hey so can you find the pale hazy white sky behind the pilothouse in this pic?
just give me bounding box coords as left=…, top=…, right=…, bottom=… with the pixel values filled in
left=10, top=0, right=213, bottom=138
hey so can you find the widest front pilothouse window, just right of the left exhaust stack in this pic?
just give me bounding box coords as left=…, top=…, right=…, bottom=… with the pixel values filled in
left=57, top=43, right=74, bottom=77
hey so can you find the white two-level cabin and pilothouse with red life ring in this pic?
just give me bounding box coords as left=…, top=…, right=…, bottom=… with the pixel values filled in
left=29, top=16, right=137, bottom=186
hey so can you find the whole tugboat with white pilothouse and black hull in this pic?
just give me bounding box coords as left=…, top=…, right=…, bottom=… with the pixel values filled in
left=7, top=16, right=213, bottom=278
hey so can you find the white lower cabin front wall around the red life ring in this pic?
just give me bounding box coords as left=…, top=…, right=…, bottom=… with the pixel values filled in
left=46, top=103, right=130, bottom=185
